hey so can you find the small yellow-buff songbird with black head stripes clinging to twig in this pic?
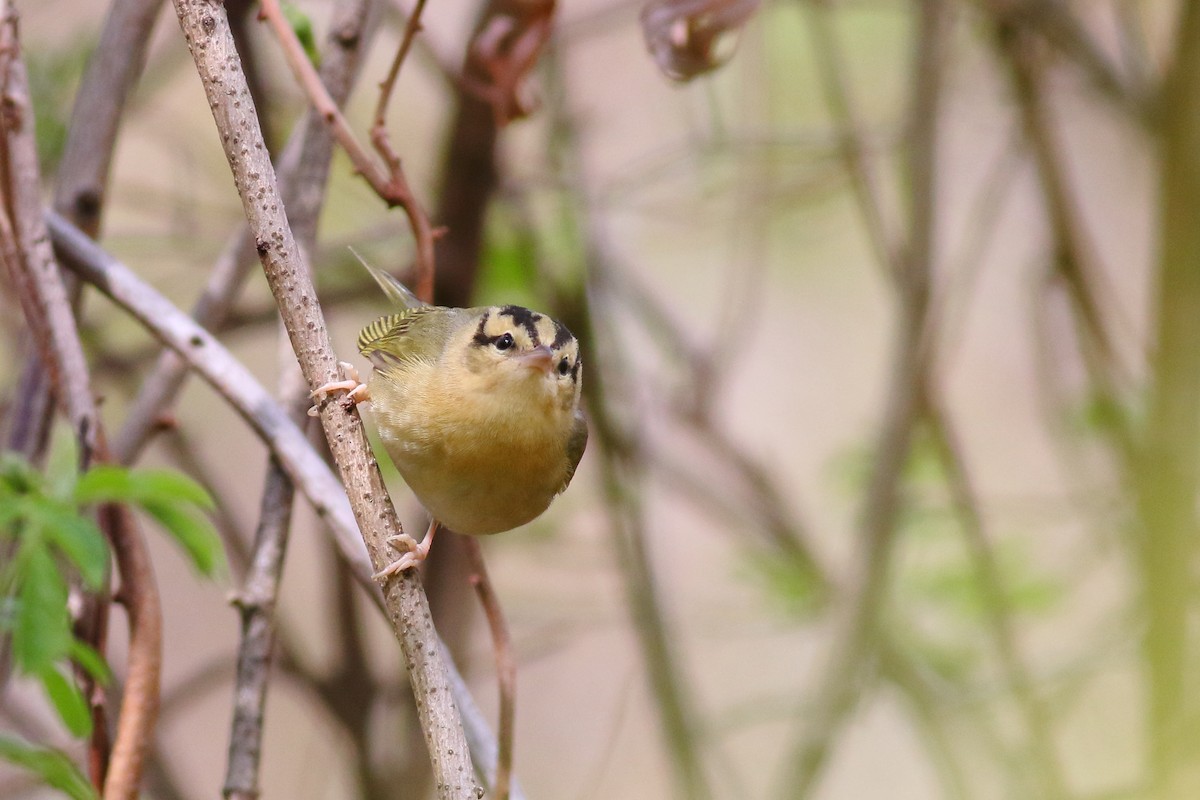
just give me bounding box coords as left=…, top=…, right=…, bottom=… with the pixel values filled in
left=313, top=260, right=588, bottom=578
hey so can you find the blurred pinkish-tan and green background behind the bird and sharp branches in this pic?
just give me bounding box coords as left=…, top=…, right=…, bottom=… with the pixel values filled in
left=0, top=0, right=1200, bottom=800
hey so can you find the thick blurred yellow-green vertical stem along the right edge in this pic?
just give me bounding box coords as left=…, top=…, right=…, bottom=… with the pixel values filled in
left=1134, top=1, right=1200, bottom=798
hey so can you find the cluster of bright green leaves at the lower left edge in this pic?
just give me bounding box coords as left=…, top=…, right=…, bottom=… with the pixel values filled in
left=0, top=453, right=223, bottom=798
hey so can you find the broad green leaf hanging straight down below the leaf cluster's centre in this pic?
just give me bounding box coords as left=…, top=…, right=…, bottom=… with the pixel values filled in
left=12, top=543, right=71, bottom=675
